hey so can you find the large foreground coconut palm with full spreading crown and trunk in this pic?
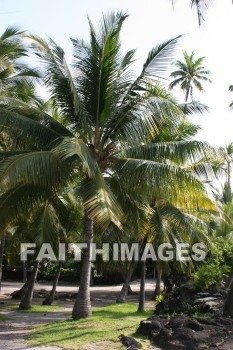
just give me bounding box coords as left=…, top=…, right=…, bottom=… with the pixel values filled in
left=0, top=12, right=215, bottom=319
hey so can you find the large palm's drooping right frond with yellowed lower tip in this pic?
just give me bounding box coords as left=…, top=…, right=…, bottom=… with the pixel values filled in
left=114, top=158, right=216, bottom=210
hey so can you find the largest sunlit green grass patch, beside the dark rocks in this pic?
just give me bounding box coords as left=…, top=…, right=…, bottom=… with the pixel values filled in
left=29, top=303, right=153, bottom=350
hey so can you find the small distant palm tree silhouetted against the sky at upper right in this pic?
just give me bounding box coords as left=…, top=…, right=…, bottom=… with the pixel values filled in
left=169, top=51, right=211, bottom=102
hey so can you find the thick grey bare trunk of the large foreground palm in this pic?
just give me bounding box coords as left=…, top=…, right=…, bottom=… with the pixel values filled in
left=72, top=216, right=93, bottom=320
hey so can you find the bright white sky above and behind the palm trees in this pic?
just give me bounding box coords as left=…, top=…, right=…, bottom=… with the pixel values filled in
left=0, top=0, right=233, bottom=146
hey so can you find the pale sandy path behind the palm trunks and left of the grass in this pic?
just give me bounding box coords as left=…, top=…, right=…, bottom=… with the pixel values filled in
left=0, top=280, right=157, bottom=350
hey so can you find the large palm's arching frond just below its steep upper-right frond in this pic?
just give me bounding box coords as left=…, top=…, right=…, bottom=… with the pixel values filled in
left=101, top=82, right=183, bottom=147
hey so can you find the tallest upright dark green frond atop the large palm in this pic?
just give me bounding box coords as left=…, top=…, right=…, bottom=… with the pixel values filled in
left=73, top=12, right=128, bottom=130
